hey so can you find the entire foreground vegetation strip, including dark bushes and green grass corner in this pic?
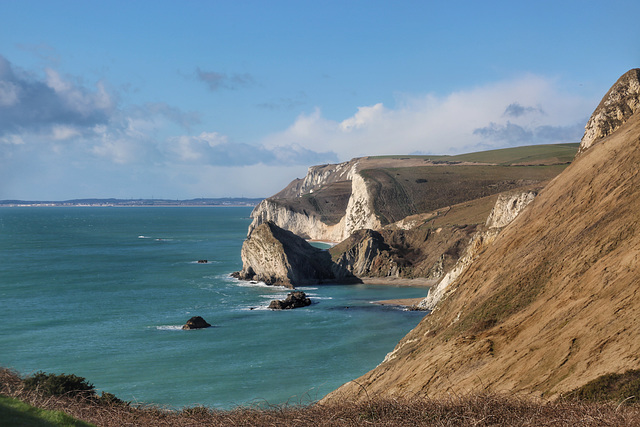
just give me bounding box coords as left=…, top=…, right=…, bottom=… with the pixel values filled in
left=0, top=369, right=640, bottom=426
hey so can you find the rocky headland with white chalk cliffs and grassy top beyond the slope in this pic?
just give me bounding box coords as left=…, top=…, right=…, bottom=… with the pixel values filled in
left=235, top=144, right=577, bottom=287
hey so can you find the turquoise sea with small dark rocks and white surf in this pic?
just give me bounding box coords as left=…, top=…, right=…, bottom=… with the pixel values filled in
left=0, top=207, right=427, bottom=409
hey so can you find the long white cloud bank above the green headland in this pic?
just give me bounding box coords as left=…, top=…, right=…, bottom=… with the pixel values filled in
left=263, top=75, right=597, bottom=160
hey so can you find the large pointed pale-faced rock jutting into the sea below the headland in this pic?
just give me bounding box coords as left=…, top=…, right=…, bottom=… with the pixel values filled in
left=233, top=221, right=357, bottom=289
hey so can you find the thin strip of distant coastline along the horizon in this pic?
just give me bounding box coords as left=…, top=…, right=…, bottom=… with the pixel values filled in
left=0, top=197, right=262, bottom=207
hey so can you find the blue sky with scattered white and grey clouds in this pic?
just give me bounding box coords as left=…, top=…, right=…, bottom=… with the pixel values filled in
left=0, top=0, right=640, bottom=200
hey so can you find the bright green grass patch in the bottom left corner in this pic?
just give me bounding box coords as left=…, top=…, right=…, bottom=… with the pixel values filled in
left=0, top=395, right=93, bottom=427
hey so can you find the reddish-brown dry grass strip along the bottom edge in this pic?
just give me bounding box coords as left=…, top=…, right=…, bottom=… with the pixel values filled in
left=0, top=369, right=640, bottom=426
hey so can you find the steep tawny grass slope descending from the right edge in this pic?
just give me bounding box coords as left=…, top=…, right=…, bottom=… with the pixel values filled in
left=325, top=70, right=640, bottom=401
